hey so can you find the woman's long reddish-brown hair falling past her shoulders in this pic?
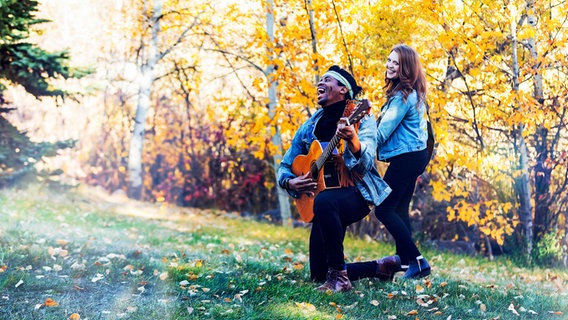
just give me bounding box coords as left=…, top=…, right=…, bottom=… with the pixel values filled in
left=385, top=44, right=426, bottom=102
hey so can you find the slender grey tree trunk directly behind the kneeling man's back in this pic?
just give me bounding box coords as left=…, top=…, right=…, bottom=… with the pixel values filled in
left=266, top=0, right=292, bottom=227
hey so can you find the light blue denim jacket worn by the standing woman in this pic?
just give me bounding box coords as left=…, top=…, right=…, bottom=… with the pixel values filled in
left=377, top=91, right=428, bottom=161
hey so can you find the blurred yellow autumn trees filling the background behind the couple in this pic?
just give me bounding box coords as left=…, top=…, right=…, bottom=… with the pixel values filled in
left=0, top=0, right=568, bottom=264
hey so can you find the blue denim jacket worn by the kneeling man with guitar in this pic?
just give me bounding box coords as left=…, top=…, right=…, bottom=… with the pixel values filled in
left=277, top=105, right=391, bottom=206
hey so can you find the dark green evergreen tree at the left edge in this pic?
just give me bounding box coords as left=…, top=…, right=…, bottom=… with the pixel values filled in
left=0, top=0, right=88, bottom=187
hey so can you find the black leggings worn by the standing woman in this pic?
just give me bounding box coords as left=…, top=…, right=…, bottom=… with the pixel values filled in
left=375, top=150, right=428, bottom=265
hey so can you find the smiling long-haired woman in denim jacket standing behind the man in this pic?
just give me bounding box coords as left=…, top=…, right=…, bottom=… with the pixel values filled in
left=375, top=44, right=430, bottom=279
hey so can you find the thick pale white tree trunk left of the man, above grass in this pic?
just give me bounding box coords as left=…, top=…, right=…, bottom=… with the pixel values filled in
left=128, top=0, right=162, bottom=199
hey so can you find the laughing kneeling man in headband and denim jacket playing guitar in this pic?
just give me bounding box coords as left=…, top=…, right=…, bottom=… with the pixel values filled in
left=278, top=66, right=400, bottom=292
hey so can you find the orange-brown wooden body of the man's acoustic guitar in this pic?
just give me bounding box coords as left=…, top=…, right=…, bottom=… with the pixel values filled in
left=292, top=140, right=325, bottom=222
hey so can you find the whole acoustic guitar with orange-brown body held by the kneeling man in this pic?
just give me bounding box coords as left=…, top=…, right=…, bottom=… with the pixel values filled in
left=291, top=99, right=371, bottom=222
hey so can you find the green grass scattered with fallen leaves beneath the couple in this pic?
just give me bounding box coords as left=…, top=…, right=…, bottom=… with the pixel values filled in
left=0, top=186, right=568, bottom=320
